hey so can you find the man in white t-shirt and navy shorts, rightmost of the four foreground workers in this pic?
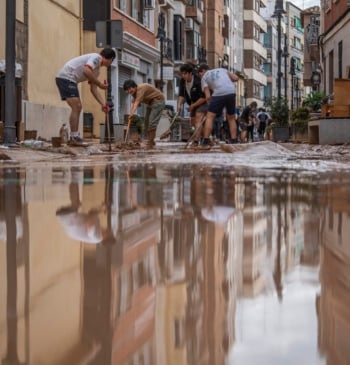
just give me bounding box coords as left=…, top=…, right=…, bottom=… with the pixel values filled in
left=198, top=64, right=238, bottom=149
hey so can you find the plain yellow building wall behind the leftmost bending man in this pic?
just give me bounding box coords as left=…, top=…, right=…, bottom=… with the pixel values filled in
left=28, top=0, right=82, bottom=106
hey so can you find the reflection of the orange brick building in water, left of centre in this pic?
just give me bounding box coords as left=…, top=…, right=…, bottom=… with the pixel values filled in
left=84, top=167, right=162, bottom=364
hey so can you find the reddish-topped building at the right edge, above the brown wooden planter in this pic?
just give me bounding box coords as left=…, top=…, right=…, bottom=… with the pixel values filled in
left=320, top=0, right=350, bottom=95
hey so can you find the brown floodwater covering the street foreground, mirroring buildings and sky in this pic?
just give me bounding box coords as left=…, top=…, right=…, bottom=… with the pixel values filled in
left=0, top=144, right=350, bottom=365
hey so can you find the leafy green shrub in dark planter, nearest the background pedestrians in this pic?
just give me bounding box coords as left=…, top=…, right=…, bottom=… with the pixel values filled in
left=268, top=97, right=289, bottom=142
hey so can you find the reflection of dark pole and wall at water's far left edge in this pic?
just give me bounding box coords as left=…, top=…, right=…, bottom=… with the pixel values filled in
left=0, top=168, right=29, bottom=365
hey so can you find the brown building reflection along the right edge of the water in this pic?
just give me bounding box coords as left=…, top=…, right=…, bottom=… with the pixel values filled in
left=317, top=182, right=350, bottom=365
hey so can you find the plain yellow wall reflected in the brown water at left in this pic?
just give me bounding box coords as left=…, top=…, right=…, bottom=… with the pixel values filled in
left=0, top=169, right=95, bottom=364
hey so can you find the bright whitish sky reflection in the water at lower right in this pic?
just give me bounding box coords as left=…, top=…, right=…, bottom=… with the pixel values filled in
left=228, top=267, right=325, bottom=365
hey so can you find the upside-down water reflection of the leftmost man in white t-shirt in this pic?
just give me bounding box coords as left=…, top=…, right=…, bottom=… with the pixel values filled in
left=56, top=172, right=104, bottom=244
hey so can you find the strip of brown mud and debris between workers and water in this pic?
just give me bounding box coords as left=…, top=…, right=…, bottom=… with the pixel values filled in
left=0, top=141, right=350, bottom=166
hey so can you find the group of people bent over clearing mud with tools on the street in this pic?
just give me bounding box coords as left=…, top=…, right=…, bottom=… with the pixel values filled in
left=56, top=48, right=270, bottom=149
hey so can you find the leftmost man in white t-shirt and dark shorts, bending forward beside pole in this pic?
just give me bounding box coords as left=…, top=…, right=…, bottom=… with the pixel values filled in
left=56, top=48, right=116, bottom=146
